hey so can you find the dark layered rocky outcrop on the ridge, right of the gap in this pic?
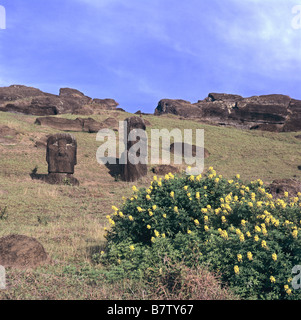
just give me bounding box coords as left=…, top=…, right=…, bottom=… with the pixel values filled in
left=155, top=93, right=301, bottom=132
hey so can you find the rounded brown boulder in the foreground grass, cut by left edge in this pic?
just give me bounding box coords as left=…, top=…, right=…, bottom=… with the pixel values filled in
left=0, top=235, right=50, bottom=269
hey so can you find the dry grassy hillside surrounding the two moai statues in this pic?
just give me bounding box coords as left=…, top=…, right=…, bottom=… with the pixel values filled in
left=0, top=111, right=301, bottom=299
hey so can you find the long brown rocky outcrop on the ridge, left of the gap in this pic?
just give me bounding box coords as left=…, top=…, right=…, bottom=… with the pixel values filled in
left=0, top=85, right=118, bottom=116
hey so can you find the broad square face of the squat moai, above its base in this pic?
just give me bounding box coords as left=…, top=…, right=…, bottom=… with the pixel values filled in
left=46, top=133, right=77, bottom=174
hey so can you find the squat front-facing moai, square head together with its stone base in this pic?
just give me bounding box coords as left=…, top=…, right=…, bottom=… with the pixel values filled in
left=46, top=133, right=78, bottom=185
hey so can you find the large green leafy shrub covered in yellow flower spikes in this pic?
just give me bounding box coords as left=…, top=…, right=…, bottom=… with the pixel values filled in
left=99, top=168, right=301, bottom=299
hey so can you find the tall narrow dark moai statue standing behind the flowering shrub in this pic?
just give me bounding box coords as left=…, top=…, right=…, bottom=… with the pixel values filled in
left=120, top=116, right=147, bottom=182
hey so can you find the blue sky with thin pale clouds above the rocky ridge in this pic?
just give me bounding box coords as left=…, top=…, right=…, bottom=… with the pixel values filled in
left=0, top=0, right=301, bottom=113
